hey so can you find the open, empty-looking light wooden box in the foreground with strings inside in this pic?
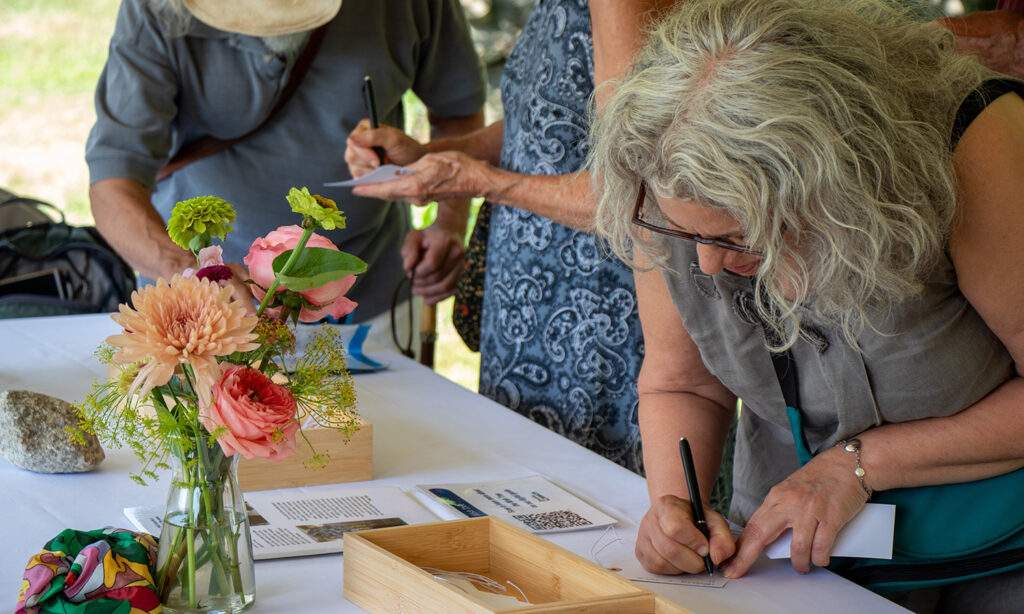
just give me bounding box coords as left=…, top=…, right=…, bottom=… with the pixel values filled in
left=343, top=517, right=690, bottom=614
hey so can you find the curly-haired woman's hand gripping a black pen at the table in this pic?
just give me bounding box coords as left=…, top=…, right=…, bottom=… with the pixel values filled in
left=636, top=494, right=736, bottom=575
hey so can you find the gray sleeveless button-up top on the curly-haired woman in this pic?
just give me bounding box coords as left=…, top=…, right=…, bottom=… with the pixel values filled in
left=665, top=249, right=1013, bottom=522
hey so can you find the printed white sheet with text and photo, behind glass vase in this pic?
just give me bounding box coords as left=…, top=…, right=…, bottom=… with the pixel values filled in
left=125, top=486, right=437, bottom=561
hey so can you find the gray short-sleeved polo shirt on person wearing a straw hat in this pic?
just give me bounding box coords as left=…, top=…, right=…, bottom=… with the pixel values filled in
left=86, top=0, right=485, bottom=321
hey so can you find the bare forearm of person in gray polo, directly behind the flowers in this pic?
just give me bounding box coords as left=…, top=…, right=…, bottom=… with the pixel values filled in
left=89, top=178, right=196, bottom=279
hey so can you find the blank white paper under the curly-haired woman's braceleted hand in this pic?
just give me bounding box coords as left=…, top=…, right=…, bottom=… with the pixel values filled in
left=765, top=503, right=896, bottom=559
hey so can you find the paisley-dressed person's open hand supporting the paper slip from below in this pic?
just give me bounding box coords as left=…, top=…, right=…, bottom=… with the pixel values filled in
left=352, top=151, right=487, bottom=206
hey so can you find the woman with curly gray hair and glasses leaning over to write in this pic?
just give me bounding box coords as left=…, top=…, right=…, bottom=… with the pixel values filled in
left=590, top=0, right=1024, bottom=612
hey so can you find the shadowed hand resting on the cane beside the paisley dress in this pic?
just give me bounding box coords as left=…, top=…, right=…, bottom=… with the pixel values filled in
left=401, top=224, right=466, bottom=305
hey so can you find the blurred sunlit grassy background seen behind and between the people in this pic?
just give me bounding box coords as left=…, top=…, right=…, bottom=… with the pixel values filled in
left=0, top=0, right=995, bottom=391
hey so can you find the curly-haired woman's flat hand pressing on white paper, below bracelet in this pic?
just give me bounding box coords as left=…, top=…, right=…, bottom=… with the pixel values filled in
left=722, top=447, right=867, bottom=578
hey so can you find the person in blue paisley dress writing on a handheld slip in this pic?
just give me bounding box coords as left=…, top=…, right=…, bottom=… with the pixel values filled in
left=345, top=0, right=670, bottom=472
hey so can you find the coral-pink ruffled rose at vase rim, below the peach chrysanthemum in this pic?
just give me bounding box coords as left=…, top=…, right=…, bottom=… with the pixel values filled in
left=200, top=362, right=299, bottom=461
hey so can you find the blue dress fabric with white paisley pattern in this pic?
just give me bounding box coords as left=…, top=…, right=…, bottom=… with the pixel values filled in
left=480, top=0, right=643, bottom=472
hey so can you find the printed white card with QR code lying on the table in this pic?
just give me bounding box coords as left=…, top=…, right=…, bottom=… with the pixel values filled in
left=417, top=476, right=616, bottom=533
